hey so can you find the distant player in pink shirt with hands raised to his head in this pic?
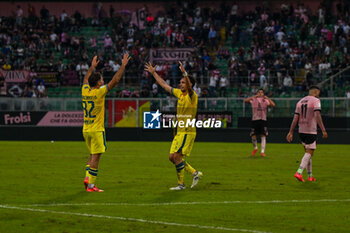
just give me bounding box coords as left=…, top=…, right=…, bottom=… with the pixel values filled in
left=244, top=88, right=276, bottom=156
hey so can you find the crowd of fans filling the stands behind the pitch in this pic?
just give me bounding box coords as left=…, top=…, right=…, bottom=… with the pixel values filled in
left=0, top=1, right=350, bottom=97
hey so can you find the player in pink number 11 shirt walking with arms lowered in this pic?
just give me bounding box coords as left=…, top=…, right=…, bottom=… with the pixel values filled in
left=287, top=86, right=328, bottom=182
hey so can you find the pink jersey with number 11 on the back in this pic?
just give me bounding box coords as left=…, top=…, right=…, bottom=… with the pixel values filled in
left=295, top=96, right=321, bottom=134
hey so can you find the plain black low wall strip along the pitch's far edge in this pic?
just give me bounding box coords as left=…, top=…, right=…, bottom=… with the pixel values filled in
left=0, top=126, right=350, bottom=144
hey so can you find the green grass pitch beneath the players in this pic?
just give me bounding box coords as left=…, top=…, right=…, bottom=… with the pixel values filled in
left=0, top=141, right=350, bottom=233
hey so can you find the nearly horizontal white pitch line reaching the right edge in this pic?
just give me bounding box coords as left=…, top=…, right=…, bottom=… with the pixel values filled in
left=16, top=199, right=350, bottom=207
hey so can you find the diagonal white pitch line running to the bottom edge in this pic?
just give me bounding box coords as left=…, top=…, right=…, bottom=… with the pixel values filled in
left=0, top=205, right=268, bottom=233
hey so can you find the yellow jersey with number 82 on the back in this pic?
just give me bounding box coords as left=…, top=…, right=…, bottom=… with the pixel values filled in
left=81, top=84, right=108, bottom=132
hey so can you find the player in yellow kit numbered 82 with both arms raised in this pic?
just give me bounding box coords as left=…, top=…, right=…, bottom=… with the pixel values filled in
left=81, top=54, right=130, bottom=192
